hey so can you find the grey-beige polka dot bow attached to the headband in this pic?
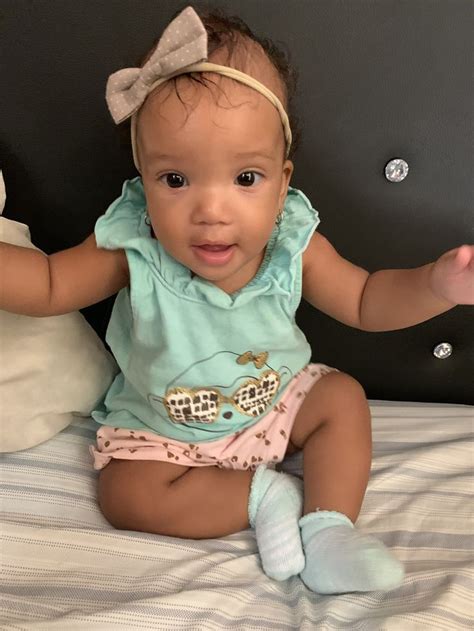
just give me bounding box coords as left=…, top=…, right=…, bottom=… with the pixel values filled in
left=105, top=7, right=207, bottom=124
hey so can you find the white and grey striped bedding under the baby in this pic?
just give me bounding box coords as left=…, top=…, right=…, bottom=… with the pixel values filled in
left=0, top=401, right=474, bottom=631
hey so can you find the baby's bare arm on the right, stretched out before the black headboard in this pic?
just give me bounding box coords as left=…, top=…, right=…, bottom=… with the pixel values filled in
left=303, top=233, right=466, bottom=331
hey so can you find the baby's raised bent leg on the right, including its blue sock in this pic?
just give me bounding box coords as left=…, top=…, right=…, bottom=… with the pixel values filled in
left=290, top=372, right=403, bottom=594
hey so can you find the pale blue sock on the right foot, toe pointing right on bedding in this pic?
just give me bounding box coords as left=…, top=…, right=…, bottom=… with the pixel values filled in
left=300, top=511, right=404, bottom=594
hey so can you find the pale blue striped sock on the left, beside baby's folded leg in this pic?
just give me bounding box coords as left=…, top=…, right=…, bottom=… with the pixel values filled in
left=249, top=465, right=304, bottom=581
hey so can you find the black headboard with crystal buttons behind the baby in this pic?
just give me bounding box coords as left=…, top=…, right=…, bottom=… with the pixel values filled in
left=0, top=0, right=474, bottom=404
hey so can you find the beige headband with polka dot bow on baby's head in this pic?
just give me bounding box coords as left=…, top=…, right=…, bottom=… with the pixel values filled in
left=105, top=7, right=292, bottom=172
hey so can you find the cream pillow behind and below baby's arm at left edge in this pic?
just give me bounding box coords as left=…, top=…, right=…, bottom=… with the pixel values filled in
left=0, top=171, right=118, bottom=452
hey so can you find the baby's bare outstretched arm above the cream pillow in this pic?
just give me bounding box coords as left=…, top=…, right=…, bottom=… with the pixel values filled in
left=0, top=234, right=129, bottom=317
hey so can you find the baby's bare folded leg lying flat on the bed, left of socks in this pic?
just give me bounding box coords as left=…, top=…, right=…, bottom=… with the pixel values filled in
left=99, top=459, right=253, bottom=539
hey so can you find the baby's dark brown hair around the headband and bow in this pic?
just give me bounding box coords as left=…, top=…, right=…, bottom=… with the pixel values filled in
left=123, top=2, right=301, bottom=160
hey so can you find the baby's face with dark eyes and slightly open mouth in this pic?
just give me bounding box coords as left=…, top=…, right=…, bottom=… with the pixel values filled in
left=137, top=75, right=293, bottom=293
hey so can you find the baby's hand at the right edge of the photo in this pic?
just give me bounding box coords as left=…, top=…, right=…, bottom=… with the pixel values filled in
left=430, top=245, right=474, bottom=305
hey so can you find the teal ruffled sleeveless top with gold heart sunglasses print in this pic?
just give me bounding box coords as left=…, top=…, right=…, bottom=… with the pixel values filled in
left=92, top=177, right=319, bottom=442
